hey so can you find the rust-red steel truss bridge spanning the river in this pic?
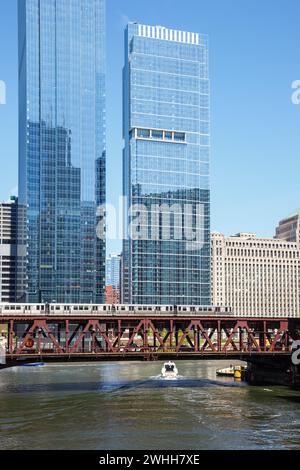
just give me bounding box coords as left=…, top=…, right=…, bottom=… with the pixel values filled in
left=0, top=312, right=293, bottom=361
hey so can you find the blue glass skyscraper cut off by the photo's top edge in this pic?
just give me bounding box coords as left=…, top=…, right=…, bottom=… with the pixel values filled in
left=18, top=0, right=106, bottom=303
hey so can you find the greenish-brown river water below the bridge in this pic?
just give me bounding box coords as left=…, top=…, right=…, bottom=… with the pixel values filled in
left=0, top=361, right=300, bottom=450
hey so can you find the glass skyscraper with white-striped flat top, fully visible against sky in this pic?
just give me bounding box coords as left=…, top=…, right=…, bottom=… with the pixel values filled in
left=122, top=24, right=210, bottom=305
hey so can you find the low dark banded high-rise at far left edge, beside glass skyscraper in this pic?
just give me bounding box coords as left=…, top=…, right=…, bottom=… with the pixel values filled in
left=0, top=197, right=26, bottom=302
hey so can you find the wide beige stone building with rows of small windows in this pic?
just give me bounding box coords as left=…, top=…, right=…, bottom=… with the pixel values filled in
left=211, top=233, right=300, bottom=317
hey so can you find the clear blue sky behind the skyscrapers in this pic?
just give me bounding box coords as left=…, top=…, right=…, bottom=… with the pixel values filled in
left=0, top=0, right=300, bottom=255
